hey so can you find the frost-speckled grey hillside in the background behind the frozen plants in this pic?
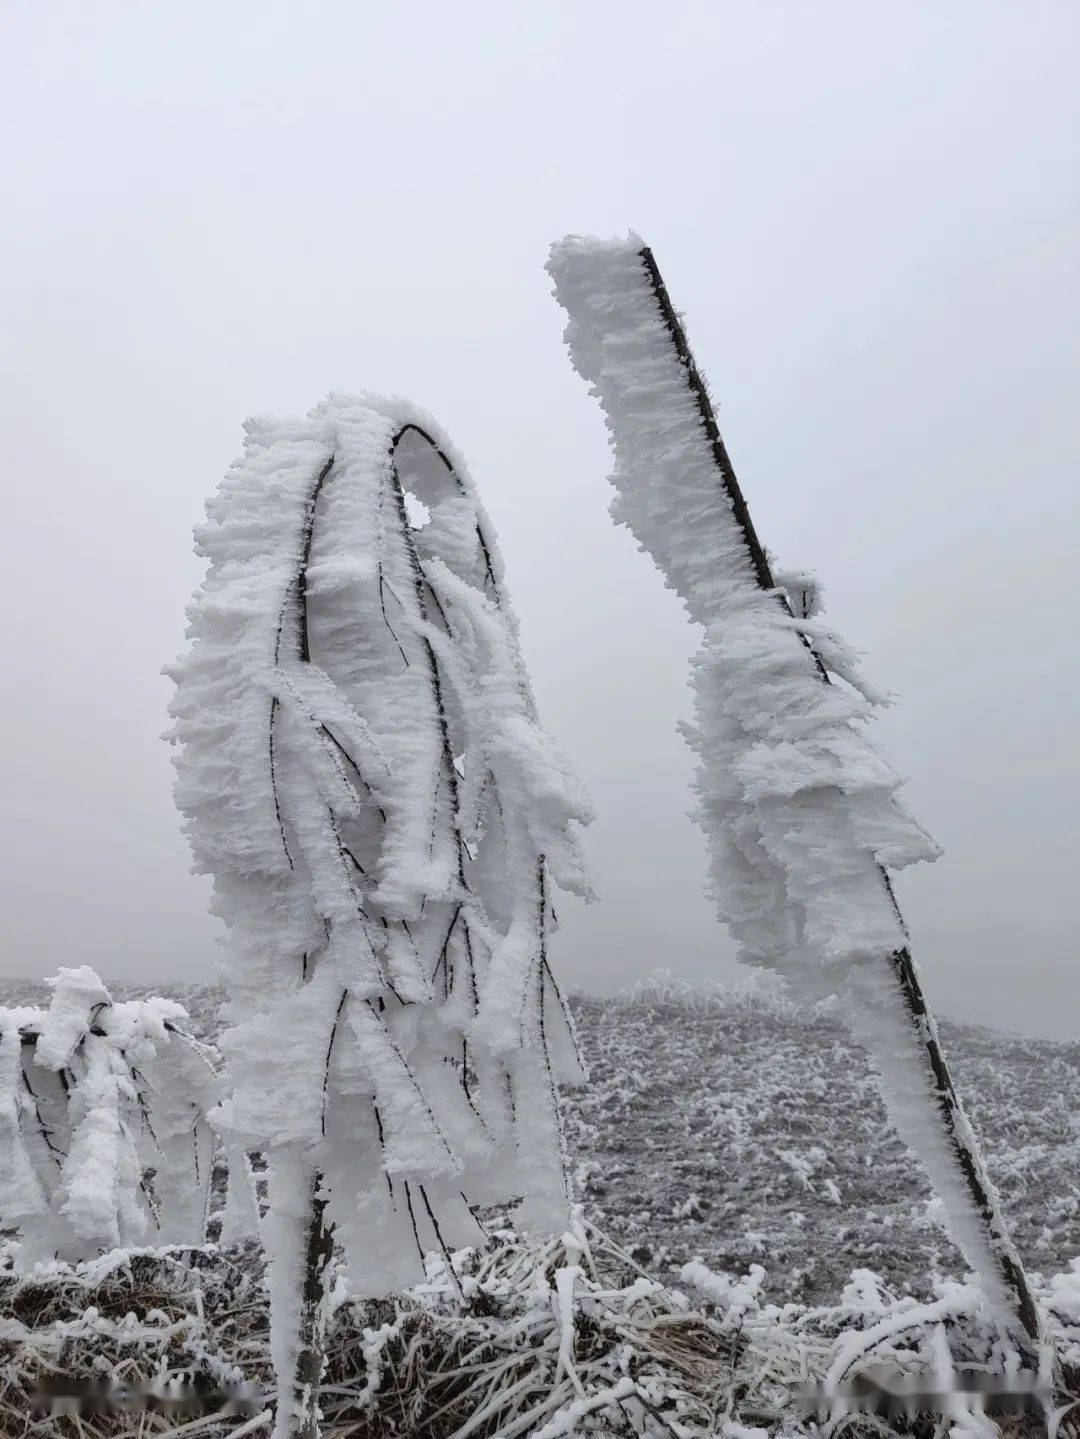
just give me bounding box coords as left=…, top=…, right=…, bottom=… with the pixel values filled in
left=0, top=980, right=1080, bottom=1304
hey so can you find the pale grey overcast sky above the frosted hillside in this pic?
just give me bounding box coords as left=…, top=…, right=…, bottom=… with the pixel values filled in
left=0, top=0, right=1080, bottom=1035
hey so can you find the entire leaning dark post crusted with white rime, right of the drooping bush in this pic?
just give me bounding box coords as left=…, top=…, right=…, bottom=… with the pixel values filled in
left=548, top=236, right=1041, bottom=1364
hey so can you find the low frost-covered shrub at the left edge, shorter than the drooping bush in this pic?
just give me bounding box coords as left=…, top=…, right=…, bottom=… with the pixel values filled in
left=0, top=966, right=220, bottom=1263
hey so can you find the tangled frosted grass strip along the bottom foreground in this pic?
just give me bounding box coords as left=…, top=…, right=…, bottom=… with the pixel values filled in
left=0, top=1216, right=1080, bottom=1439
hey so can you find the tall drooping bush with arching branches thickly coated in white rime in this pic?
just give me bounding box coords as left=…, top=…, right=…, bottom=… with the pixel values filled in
left=171, top=394, right=588, bottom=1295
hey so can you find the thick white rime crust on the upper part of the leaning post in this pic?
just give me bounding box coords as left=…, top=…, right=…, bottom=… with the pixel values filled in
left=549, top=237, right=938, bottom=993
